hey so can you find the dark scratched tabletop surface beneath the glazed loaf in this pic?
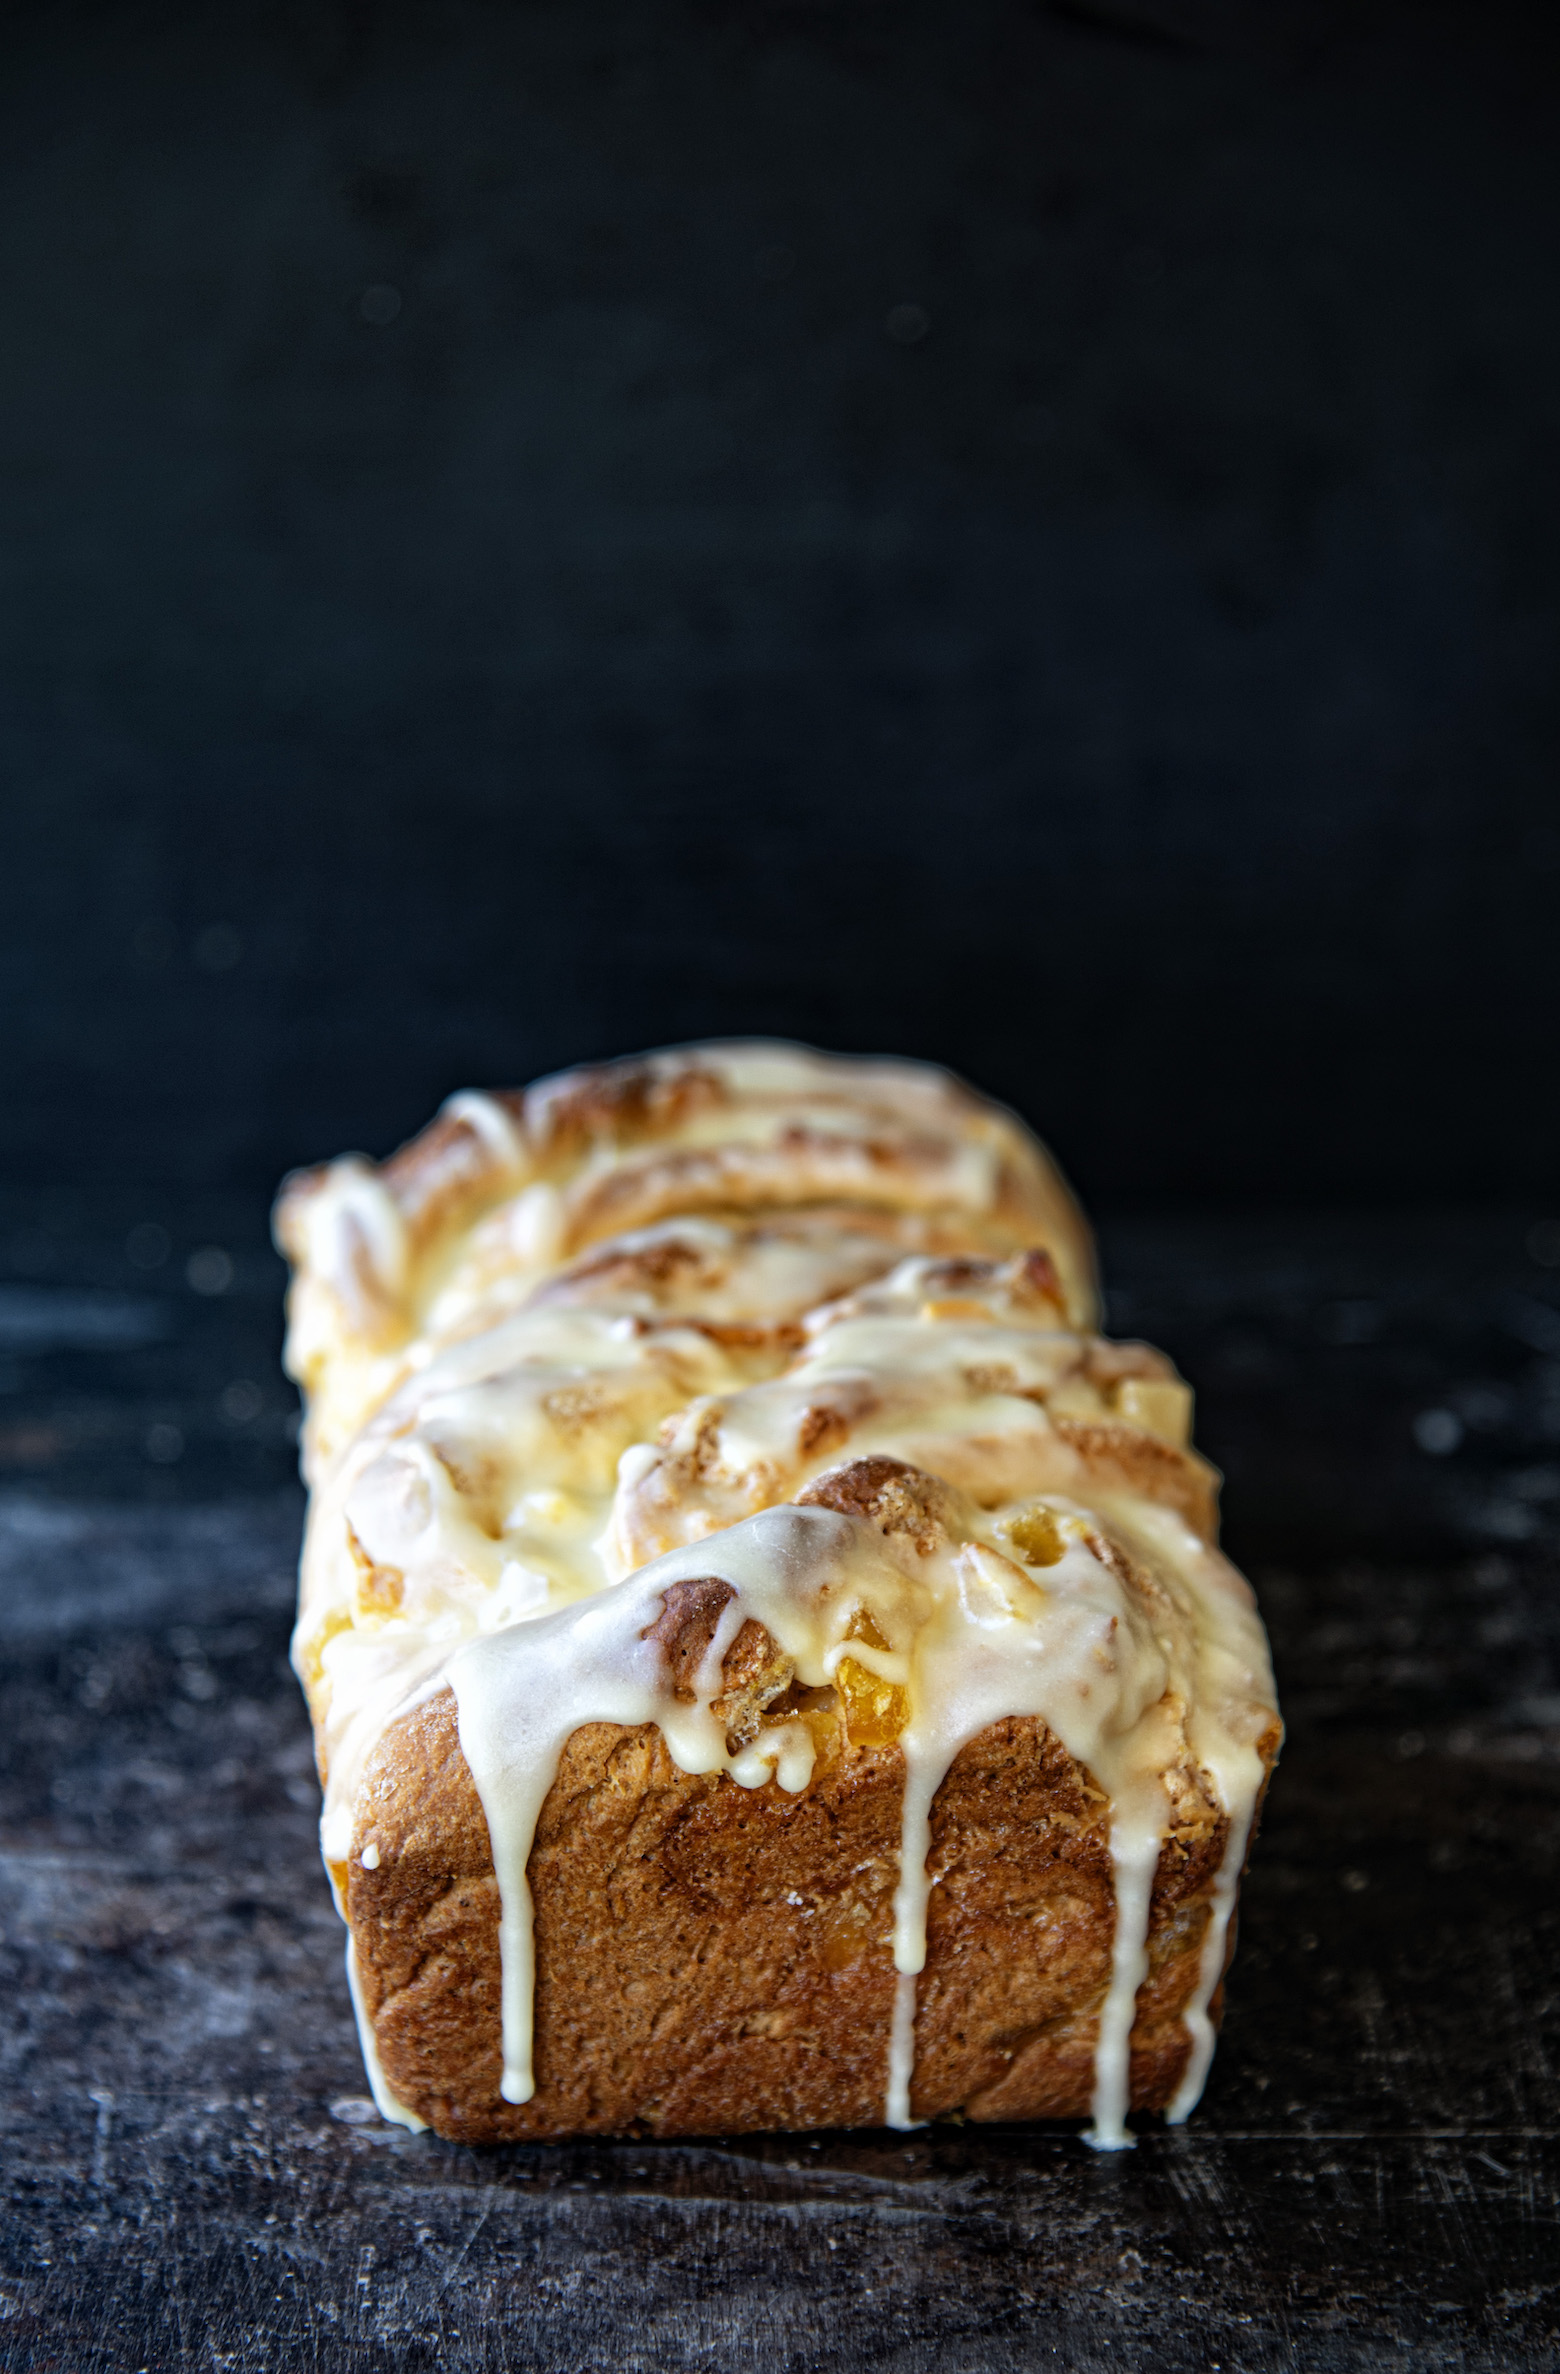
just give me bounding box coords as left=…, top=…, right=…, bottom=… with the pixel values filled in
left=0, top=1199, right=1560, bottom=2374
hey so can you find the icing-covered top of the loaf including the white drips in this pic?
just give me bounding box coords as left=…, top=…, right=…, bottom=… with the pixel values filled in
left=278, top=1045, right=1275, bottom=2139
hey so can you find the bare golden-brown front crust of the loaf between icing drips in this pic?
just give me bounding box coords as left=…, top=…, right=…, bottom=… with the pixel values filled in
left=347, top=1680, right=1275, bottom=2141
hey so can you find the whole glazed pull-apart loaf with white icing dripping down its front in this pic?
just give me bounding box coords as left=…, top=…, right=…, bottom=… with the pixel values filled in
left=278, top=1045, right=1280, bottom=2148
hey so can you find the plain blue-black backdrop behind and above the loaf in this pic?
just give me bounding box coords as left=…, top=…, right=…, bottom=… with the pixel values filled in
left=0, top=0, right=1560, bottom=1208
